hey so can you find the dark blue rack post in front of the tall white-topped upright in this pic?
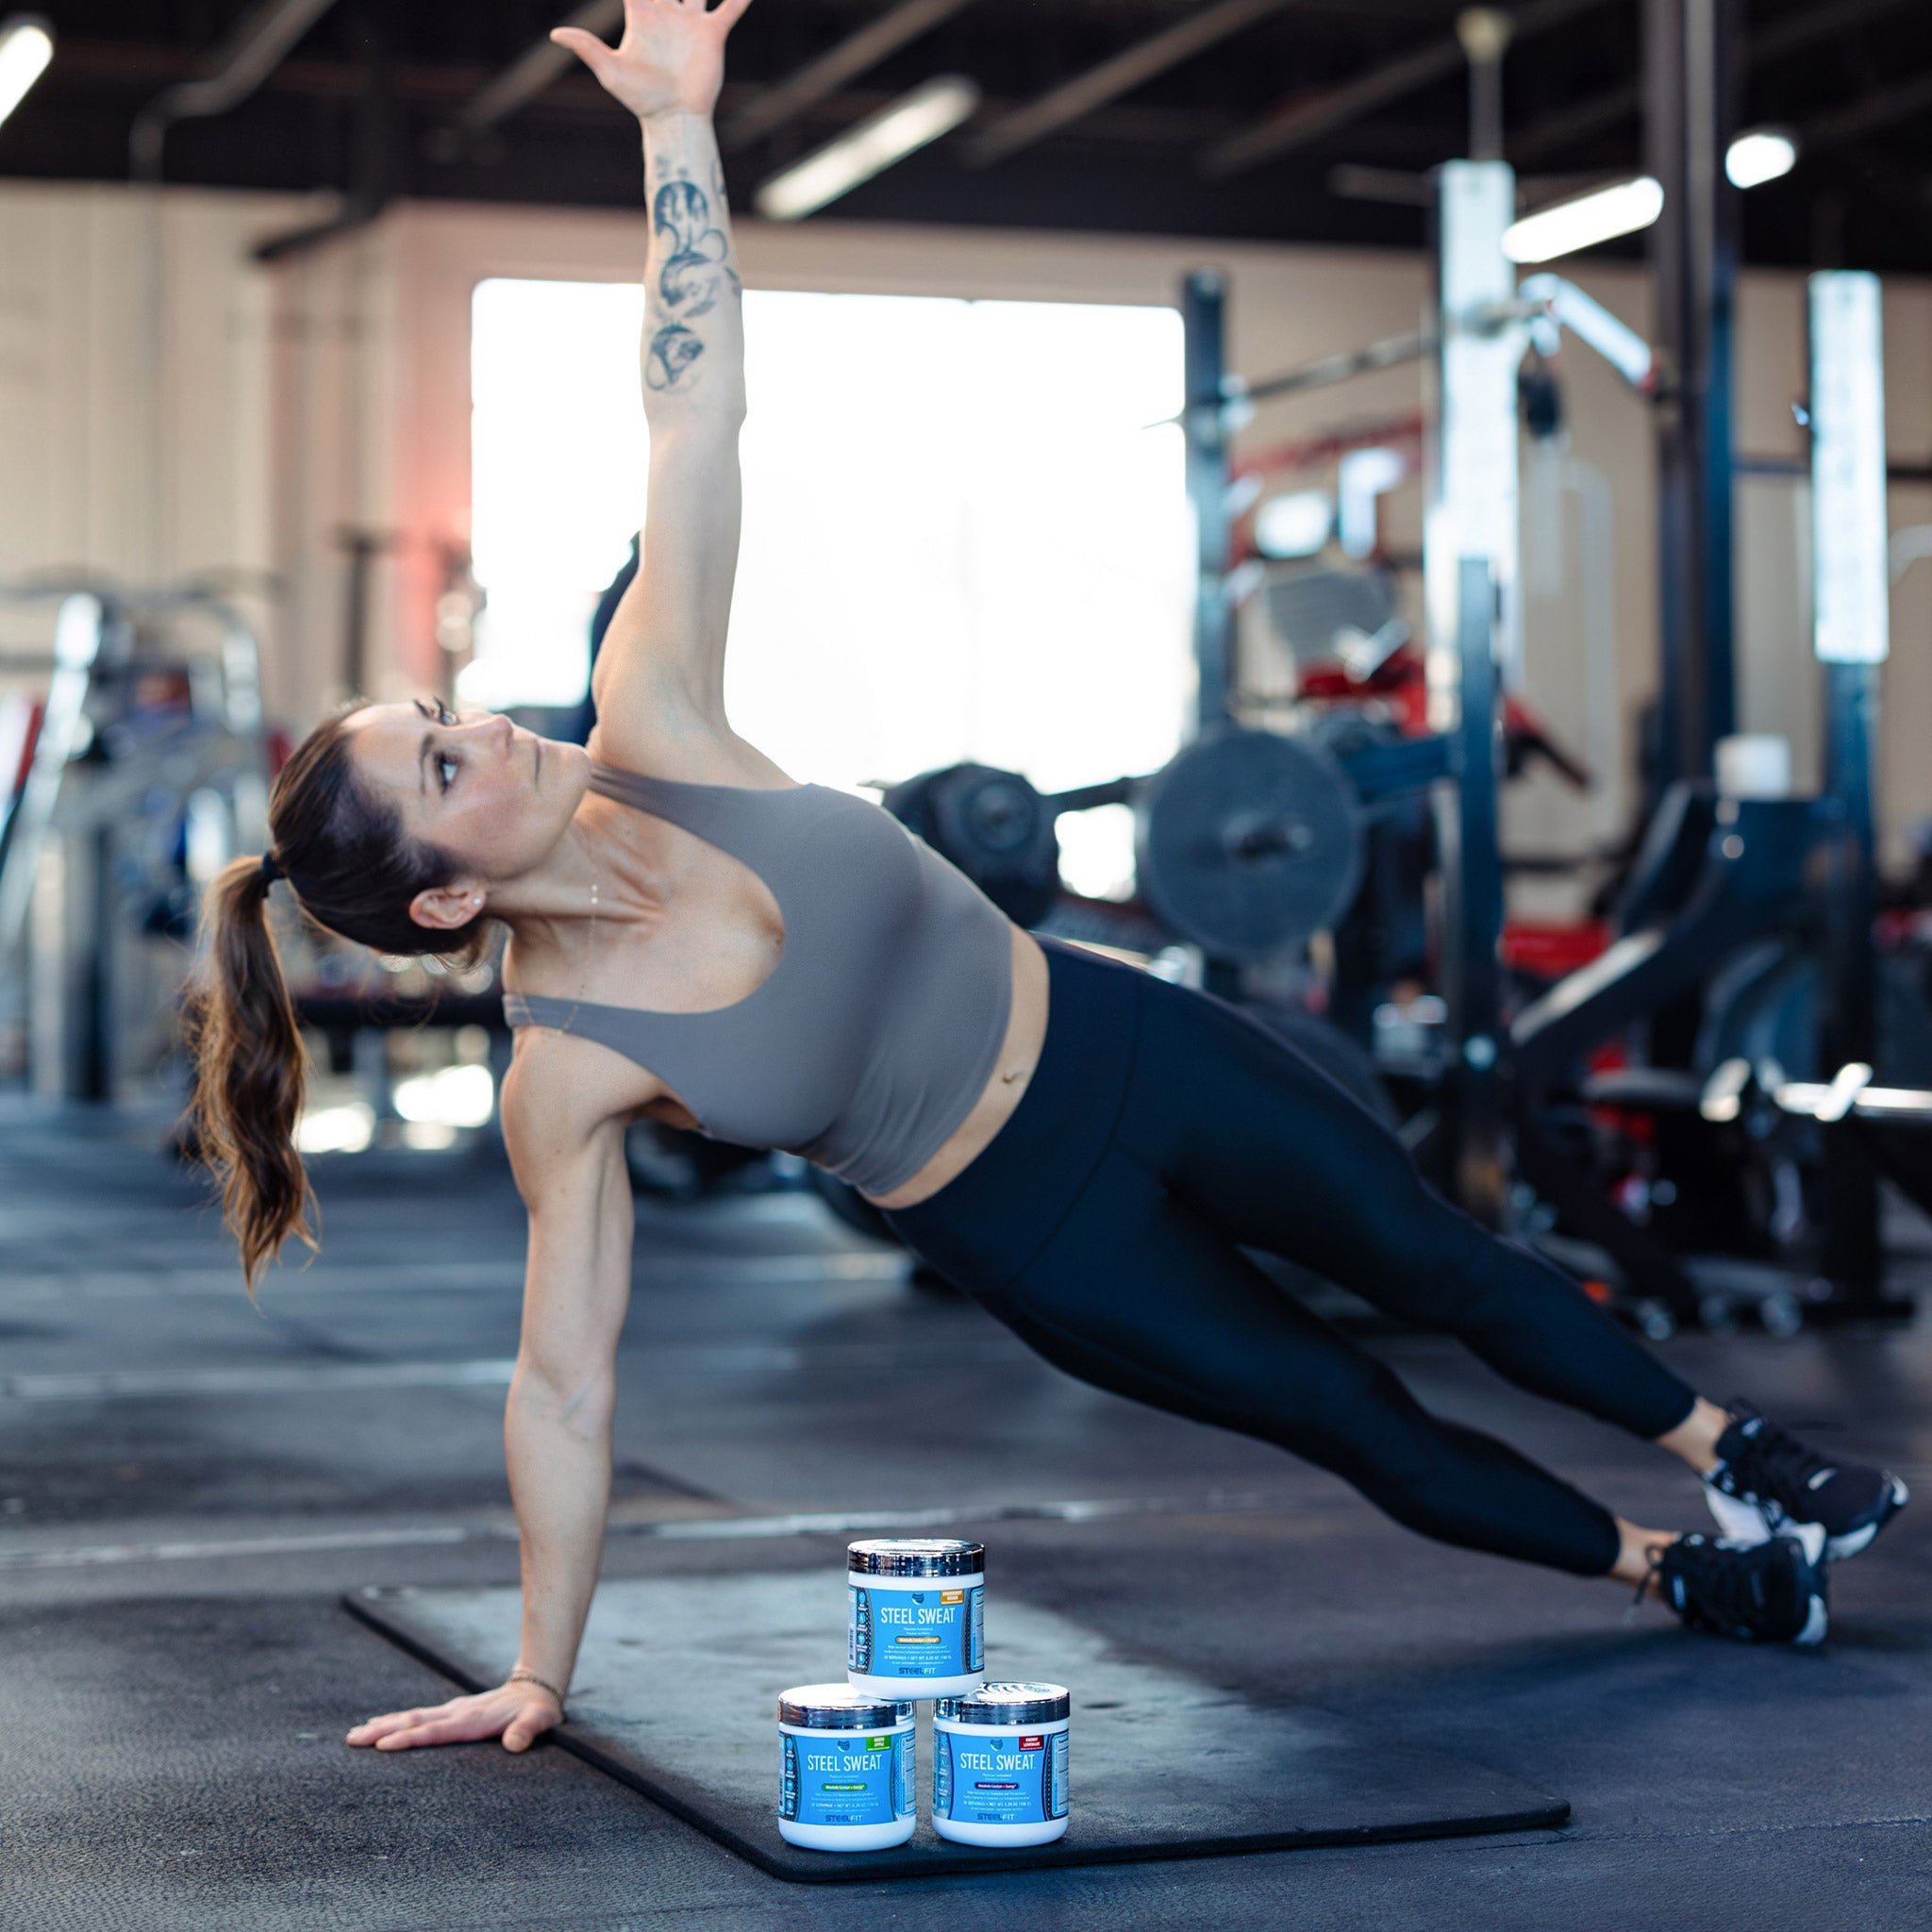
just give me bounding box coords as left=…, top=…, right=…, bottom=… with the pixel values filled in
left=1440, top=557, right=1508, bottom=1226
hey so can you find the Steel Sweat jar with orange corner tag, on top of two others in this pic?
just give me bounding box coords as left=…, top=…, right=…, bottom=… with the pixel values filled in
left=846, top=1538, right=985, bottom=1696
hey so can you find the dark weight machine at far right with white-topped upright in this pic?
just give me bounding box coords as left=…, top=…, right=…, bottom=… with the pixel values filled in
left=1513, top=275, right=1901, bottom=1325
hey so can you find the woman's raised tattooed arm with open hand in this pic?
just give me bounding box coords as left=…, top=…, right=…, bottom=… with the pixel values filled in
left=553, top=0, right=750, bottom=776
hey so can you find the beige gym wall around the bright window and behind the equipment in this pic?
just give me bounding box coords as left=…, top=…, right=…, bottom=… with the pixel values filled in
left=0, top=184, right=1932, bottom=873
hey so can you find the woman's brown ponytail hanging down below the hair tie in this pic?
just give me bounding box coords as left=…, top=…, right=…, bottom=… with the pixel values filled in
left=188, top=858, right=315, bottom=1294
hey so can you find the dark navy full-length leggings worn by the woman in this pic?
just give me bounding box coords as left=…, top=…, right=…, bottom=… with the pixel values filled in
left=889, top=947, right=1694, bottom=1576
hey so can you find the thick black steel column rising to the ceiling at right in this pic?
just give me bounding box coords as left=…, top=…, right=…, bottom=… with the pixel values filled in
left=1644, top=0, right=1740, bottom=791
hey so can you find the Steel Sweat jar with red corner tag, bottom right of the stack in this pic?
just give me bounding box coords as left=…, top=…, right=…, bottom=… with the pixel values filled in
left=933, top=1685, right=1073, bottom=1845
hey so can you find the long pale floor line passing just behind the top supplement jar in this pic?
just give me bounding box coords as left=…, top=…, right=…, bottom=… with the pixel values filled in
left=0, top=1491, right=1279, bottom=1571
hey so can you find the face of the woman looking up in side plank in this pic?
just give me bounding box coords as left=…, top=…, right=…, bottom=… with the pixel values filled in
left=348, top=699, right=591, bottom=885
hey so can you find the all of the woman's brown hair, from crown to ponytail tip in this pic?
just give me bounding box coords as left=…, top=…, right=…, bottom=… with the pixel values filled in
left=188, top=706, right=489, bottom=1294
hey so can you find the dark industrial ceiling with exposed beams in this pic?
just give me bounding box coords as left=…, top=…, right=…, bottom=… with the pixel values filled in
left=0, top=0, right=1932, bottom=271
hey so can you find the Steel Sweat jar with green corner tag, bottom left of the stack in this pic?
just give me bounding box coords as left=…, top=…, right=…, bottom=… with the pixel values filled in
left=778, top=1685, right=920, bottom=1851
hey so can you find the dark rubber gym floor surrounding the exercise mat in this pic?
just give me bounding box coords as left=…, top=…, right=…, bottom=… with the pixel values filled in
left=0, top=1105, right=1932, bottom=1932
